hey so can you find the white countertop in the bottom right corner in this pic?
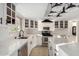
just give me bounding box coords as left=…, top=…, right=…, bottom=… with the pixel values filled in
left=58, top=43, right=79, bottom=56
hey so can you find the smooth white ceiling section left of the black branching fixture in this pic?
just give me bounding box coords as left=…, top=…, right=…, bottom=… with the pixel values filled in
left=16, top=3, right=48, bottom=18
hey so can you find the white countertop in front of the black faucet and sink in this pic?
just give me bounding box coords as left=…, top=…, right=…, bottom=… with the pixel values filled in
left=0, top=39, right=27, bottom=56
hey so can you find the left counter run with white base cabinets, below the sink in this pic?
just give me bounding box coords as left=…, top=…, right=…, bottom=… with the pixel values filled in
left=0, top=35, right=37, bottom=56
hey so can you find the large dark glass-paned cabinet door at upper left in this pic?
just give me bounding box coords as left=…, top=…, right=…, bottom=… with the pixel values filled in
left=6, top=3, right=15, bottom=24
